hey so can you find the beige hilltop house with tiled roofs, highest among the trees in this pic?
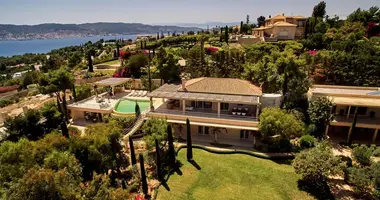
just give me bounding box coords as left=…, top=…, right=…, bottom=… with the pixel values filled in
left=252, top=14, right=307, bottom=42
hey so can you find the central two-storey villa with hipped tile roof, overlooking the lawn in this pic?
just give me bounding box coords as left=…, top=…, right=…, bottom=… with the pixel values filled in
left=147, top=77, right=282, bottom=147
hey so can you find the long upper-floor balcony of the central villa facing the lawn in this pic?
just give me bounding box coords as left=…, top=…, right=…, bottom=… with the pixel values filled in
left=147, top=104, right=258, bottom=127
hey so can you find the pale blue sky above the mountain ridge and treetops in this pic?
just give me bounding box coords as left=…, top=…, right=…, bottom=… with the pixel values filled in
left=0, top=0, right=380, bottom=24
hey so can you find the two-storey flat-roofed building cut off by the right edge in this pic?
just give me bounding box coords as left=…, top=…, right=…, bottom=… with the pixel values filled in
left=309, top=85, right=380, bottom=144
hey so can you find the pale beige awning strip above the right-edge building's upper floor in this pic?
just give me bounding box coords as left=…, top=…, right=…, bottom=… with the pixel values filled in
left=329, top=97, right=380, bottom=107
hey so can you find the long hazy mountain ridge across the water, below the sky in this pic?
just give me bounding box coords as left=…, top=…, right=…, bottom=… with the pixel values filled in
left=0, top=22, right=201, bottom=40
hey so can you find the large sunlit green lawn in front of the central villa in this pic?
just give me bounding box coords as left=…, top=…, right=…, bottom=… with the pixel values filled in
left=157, top=149, right=313, bottom=200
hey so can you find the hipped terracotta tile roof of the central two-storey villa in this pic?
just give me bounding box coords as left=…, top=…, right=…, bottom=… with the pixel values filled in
left=179, top=77, right=262, bottom=96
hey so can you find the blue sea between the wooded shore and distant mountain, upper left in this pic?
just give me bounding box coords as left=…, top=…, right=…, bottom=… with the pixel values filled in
left=0, top=35, right=137, bottom=57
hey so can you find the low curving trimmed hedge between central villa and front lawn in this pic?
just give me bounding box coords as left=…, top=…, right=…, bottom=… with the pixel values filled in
left=176, top=144, right=294, bottom=160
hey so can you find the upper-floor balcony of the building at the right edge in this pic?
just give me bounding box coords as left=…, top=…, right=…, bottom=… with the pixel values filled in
left=331, top=115, right=380, bottom=129
